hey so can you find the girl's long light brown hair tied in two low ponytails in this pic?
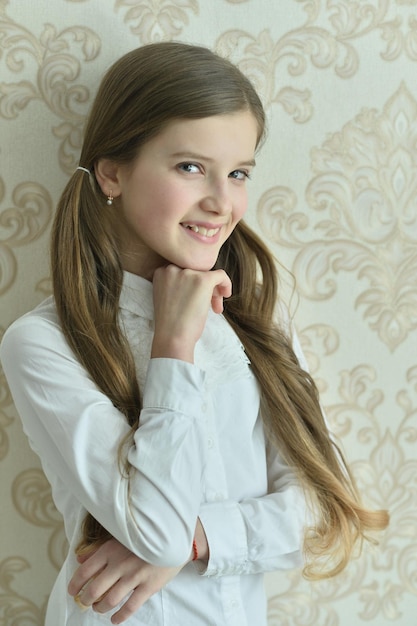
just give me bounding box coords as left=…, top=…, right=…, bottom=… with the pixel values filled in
left=51, top=42, right=388, bottom=578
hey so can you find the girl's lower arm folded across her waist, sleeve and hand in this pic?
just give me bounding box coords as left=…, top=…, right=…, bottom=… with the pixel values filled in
left=65, top=450, right=306, bottom=624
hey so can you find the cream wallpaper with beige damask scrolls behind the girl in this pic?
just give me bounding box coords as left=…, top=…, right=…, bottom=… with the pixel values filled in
left=0, top=0, right=417, bottom=626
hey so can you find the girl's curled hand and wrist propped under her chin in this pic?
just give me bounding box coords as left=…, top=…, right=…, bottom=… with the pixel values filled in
left=152, top=265, right=232, bottom=363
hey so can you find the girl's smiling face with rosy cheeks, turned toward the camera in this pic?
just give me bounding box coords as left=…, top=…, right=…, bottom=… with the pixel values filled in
left=106, top=111, right=258, bottom=279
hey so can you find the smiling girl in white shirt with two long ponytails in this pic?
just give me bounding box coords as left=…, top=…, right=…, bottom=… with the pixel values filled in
left=1, top=43, right=388, bottom=626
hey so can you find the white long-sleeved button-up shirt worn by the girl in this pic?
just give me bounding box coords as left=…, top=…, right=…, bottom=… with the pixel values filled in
left=1, top=273, right=306, bottom=626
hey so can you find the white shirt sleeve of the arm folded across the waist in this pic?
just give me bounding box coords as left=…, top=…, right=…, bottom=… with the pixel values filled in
left=197, top=320, right=312, bottom=576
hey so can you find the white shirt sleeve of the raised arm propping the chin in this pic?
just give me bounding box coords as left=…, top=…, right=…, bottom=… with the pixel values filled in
left=0, top=316, right=205, bottom=566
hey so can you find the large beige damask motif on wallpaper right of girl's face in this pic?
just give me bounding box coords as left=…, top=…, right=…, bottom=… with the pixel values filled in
left=258, top=85, right=417, bottom=351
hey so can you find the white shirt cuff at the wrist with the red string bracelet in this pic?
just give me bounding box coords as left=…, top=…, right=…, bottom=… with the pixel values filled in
left=196, top=500, right=248, bottom=576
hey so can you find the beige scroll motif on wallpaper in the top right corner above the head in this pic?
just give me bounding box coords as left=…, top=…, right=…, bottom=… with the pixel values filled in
left=216, top=0, right=417, bottom=123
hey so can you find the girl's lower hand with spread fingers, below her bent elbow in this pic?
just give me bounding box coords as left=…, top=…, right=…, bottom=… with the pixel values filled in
left=68, top=539, right=182, bottom=624
